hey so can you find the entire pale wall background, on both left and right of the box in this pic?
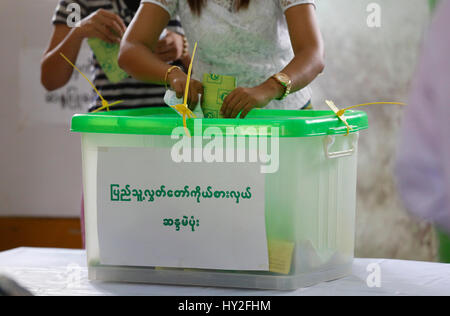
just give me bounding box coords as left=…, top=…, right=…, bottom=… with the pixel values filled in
left=0, top=0, right=436, bottom=260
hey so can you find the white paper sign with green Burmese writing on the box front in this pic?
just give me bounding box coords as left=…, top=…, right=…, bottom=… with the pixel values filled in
left=97, top=148, right=269, bottom=271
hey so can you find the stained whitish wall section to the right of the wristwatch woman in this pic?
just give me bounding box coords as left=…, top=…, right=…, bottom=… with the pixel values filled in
left=313, top=0, right=436, bottom=260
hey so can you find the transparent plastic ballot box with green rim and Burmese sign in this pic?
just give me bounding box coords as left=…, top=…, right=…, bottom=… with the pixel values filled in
left=71, top=108, right=368, bottom=290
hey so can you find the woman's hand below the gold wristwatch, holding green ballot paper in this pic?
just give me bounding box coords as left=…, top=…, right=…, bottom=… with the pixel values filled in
left=220, top=78, right=283, bottom=118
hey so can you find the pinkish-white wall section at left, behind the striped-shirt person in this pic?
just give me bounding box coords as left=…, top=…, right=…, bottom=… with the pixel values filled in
left=0, top=0, right=88, bottom=217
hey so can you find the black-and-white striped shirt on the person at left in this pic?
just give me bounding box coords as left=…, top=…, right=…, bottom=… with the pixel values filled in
left=52, top=0, right=184, bottom=111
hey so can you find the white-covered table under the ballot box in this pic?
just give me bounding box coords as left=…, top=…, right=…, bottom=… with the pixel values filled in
left=0, top=248, right=450, bottom=296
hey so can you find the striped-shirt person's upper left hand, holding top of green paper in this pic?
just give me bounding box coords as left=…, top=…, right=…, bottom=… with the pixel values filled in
left=74, top=9, right=126, bottom=43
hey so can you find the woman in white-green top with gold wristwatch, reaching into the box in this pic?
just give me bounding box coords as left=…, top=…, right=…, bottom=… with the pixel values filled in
left=119, top=0, right=324, bottom=118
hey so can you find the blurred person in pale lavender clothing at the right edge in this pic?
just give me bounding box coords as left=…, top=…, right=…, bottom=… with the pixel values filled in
left=396, top=0, right=450, bottom=234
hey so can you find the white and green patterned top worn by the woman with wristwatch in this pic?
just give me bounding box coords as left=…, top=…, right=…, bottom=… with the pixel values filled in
left=142, top=0, right=314, bottom=109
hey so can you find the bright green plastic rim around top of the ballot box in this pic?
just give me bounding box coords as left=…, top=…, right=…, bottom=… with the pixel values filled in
left=71, top=107, right=369, bottom=137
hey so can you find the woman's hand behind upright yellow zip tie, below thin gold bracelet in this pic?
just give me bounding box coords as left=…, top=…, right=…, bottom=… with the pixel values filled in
left=167, top=68, right=203, bottom=110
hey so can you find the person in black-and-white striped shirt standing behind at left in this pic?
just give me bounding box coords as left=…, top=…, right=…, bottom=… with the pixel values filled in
left=41, top=0, right=189, bottom=111
